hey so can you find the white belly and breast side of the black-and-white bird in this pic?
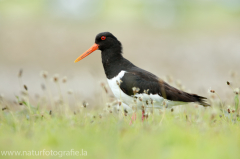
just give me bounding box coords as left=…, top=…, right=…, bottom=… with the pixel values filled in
left=107, top=71, right=188, bottom=108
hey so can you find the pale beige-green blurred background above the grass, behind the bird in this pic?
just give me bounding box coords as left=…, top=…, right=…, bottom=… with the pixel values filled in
left=0, top=0, right=240, bottom=103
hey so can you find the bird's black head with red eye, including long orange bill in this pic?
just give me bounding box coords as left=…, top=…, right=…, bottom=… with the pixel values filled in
left=74, top=32, right=122, bottom=62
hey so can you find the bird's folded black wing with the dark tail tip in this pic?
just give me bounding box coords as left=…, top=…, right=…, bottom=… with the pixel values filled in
left=120, top=67, right=209, bottom=106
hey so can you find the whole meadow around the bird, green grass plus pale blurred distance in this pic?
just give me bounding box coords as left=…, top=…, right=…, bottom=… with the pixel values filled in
left=0, top=0, right=240, bottom=159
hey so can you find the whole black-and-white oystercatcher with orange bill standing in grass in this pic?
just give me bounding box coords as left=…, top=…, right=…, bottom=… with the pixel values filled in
left=74, top=32, right=209, bottom=115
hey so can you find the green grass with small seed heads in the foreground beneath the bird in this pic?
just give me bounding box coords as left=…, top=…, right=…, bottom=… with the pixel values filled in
left=0, top=70, right=240, bottom=159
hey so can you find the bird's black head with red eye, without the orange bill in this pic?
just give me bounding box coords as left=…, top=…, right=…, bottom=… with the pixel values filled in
left=95, top=32, right=122, bottom=51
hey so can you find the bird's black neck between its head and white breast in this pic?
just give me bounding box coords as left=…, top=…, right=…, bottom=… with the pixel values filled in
left=102, top=49, right=134, bottom=79
